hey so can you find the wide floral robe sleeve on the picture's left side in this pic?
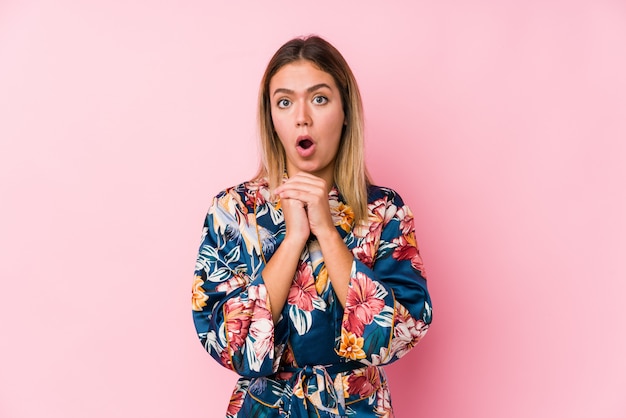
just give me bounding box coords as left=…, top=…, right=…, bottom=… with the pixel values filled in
left=192, top=191, right=287, bottom=377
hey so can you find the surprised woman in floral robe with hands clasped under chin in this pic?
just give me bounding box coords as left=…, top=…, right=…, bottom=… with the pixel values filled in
left=193, top=36, right=431, bottom=417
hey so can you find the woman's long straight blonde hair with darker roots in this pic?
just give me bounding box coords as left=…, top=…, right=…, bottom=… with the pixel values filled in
left=257, top=36, right=371, bottom=223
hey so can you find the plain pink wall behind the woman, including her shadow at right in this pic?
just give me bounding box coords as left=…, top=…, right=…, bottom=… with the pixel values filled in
left=0, top=0, right=626, bottom=418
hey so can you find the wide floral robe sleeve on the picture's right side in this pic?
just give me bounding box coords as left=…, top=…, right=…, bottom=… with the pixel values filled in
left=336, top=191, right=432, bottom=365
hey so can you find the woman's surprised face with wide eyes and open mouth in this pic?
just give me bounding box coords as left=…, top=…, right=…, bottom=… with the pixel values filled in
left=269, top=60, right=345, bottom=185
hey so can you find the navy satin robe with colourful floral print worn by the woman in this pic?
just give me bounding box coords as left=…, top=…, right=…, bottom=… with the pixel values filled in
left=192, top=181, right=431, bottom=418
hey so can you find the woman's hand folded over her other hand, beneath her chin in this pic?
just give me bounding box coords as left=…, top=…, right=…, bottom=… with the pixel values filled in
left=274, top=172, right=336, bottom=238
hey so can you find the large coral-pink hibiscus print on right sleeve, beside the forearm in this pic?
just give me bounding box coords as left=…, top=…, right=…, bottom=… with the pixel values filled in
left=342, top=272, right=385, bottom=336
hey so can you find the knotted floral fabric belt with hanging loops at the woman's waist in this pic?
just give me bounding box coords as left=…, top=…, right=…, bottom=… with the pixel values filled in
left=280, top=363, right=358, bottom=418
